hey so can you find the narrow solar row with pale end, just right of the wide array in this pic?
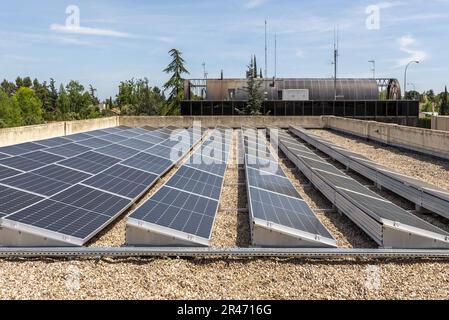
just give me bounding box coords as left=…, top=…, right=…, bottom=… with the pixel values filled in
left=127, top=128, right=232, bottom=246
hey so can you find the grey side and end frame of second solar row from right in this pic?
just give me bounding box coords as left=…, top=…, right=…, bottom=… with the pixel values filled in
left=280, top=136, right=449, bottom=249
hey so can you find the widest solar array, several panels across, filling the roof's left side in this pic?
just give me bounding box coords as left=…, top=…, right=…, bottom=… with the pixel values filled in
left=0, top=127, right=201, bottom=246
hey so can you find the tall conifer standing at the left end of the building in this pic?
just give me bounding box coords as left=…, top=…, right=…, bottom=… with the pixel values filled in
left=164, top=49, right=189, bottom=115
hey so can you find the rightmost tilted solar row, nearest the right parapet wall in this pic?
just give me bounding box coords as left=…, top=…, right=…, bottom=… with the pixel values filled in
left=291, top=127, right=449, bottom=218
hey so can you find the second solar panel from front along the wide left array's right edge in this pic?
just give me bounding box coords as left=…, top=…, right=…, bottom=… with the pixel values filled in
left=83, top=165, right=158, bottom=199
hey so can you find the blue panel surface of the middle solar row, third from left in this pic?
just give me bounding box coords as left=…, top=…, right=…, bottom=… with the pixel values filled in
left=242, top=130, right=335, bottom=246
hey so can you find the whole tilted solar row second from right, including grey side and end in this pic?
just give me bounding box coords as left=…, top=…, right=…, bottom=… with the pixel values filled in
left=279, top=129, right=449, bottom=249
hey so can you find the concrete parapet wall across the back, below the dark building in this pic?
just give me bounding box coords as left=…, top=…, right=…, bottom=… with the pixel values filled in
left=119, top=116, right=323, bottom=128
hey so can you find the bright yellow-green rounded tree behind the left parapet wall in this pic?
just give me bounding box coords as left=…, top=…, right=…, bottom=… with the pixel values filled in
left=12, top=87, right=43, bottom=125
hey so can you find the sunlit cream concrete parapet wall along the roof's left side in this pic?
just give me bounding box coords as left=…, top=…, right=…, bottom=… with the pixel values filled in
left=0, top=117, right=118, bottom=147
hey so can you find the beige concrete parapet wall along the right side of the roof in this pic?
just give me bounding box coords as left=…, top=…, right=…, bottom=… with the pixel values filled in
left=323, top=116, right=449, bottom=159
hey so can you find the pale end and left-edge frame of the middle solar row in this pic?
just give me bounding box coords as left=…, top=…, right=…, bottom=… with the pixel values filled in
left=241, top=129, right=337, bottom=248
